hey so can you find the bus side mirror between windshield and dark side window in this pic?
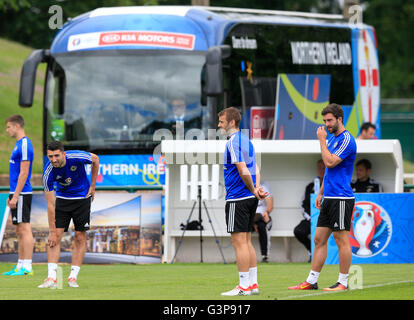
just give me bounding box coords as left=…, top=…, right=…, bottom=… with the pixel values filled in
left=205, top=45, right=231, bottom=97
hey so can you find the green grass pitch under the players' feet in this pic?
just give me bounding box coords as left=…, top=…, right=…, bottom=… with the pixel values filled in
left=0, top=263, right=414, bottom=300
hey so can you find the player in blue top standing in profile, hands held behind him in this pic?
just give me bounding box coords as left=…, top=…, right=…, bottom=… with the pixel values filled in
left=218, top=107, right=268, bottom=296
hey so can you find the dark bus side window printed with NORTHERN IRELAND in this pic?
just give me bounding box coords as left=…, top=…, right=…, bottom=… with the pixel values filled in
left=223, top=24, right=354, bottom=134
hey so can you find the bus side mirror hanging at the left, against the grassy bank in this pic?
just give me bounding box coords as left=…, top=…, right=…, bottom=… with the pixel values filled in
left=19, top=49, right=50, bottom=107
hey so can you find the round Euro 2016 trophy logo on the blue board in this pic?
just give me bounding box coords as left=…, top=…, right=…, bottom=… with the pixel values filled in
left=349, top=201, right=392, bottom=258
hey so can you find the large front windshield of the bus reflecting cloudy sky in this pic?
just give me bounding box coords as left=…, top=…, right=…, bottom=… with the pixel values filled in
left=46, top=50, right=205, bottom=153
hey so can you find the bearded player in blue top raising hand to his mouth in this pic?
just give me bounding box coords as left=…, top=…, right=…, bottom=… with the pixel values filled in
left=289, top=103, right=357, bottom=291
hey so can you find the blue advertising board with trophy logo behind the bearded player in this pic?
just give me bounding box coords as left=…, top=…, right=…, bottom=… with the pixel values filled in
left=311, top=193, right=414, bottom=264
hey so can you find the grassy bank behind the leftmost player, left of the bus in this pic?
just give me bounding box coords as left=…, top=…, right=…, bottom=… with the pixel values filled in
left=0, top=38, right=46, bottom=174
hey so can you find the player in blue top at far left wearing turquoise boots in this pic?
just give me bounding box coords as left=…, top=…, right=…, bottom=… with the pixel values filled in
left=3, top=115, right=34, bottom=276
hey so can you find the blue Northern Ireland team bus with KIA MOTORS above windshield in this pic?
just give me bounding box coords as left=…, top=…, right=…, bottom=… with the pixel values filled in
left=19, top=6, right=381, bottom=186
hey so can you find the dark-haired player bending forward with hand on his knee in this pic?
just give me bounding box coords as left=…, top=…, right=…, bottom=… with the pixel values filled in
left=39, top=141, right=99, bottom=288
